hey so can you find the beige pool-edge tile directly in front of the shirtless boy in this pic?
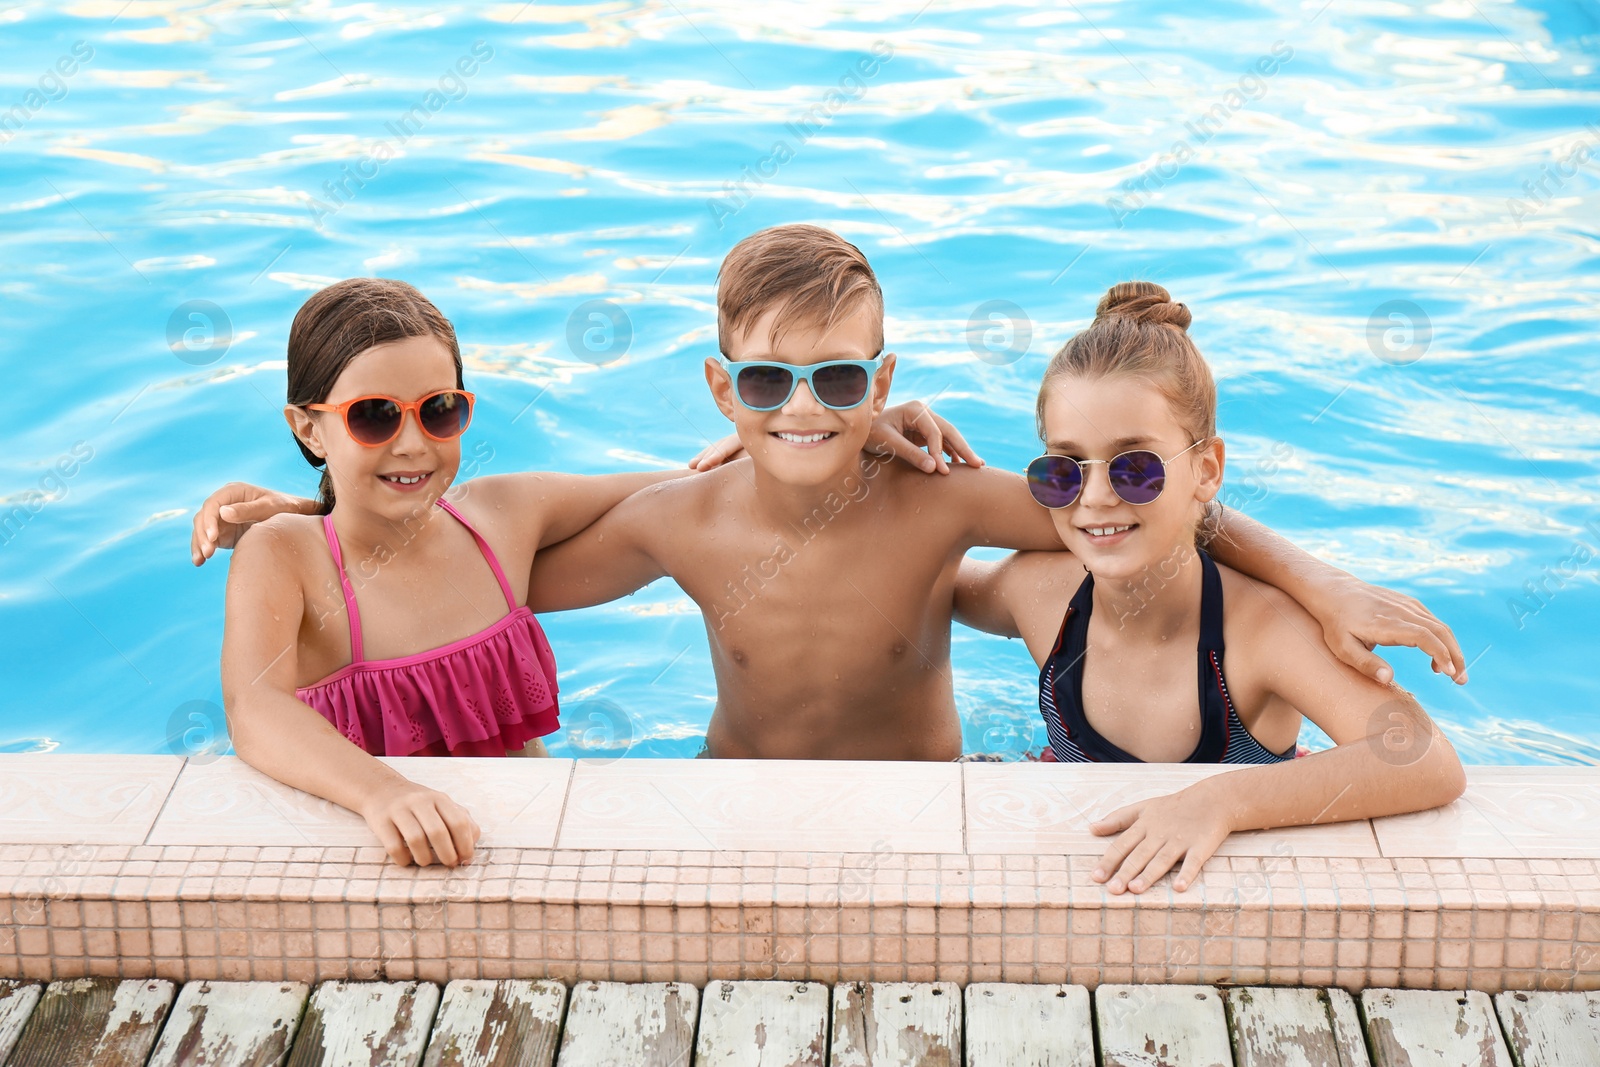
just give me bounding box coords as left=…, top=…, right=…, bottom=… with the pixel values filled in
left=562, top=760, right=962, bottom=854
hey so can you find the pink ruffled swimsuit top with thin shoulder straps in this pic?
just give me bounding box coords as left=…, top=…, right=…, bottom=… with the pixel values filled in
left=294, top=498, right=560, bottom=757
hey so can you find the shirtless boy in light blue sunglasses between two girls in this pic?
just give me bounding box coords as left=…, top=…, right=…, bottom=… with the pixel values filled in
left=193, top=226, right=1461, bottom=760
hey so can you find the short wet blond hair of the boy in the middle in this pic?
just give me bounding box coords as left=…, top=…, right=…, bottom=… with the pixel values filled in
left=717, top=224, right=883, bottom=357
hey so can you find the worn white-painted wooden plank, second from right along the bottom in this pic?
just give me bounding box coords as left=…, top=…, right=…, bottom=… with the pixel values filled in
left=1362, top=989, right=1512, bottom=1067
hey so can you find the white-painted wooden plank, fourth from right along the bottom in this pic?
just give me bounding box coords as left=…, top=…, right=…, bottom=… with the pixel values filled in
left=1094, top=985, right=1234, bottom=1067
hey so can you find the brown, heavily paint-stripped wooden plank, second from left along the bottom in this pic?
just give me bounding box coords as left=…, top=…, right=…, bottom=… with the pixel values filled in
left=6, top=977, right=174, bottom=1067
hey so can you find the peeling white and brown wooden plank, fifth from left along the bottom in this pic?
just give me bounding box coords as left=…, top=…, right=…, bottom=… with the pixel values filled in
left=422, top=979, right=566, bottom=1067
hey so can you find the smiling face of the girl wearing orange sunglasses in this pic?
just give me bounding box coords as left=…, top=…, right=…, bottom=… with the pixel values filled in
left=283, top=336, right=461, bottom=522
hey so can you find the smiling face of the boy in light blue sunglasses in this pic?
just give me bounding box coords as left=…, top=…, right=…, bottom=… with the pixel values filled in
left=706, top=301, right=894, bottom=486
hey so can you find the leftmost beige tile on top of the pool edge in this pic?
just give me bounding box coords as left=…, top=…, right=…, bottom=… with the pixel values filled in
left=0, top=752, right=184, bottom=845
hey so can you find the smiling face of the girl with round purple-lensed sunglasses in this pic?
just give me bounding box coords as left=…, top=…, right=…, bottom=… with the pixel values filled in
left=1043, top=374, right=1224, bottom=577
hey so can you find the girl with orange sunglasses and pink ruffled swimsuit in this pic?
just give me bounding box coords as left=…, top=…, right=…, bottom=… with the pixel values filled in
left=216, top=278, right=690, bottom=865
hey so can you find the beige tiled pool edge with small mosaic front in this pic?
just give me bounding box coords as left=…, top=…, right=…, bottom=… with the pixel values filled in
left=0, top=755, right=1600, bottom=992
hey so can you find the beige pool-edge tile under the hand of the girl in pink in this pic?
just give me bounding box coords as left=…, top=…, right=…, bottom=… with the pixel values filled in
left=150, top=757, right=573, bottom=848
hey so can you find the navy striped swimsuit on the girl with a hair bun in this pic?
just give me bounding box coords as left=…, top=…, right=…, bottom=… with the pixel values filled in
left=1038, top=552, right=1294, bottom=763
